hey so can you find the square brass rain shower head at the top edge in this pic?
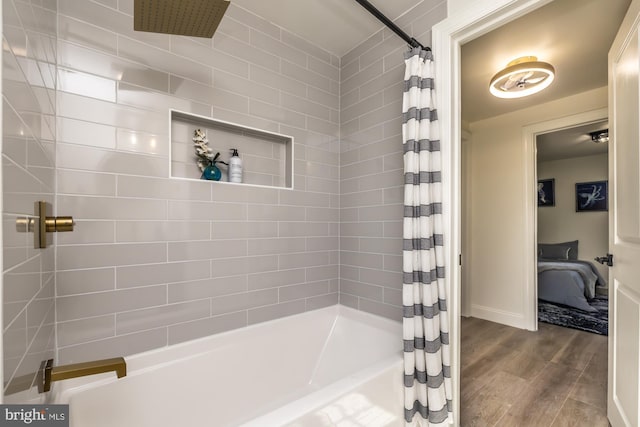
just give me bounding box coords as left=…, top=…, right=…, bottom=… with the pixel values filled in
left=133, top=0, right=229, bottom=38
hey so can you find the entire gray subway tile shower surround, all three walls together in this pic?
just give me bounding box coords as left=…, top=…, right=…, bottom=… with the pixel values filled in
left=2, top=0, right=446, bottom=402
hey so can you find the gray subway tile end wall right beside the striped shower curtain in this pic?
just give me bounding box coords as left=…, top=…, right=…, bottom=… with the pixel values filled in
left=340, top=1, right=446, bottom=320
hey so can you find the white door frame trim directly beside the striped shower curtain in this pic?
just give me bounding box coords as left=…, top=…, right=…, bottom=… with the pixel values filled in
left=431, top=0, right=552, bottom=425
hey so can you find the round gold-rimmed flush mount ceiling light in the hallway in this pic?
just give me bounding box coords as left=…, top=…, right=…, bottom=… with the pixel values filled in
left=489, top=56, right=555, bottom=98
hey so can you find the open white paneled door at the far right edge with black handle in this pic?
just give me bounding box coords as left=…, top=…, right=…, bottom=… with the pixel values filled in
left=607, top=0, right=640, bottom=427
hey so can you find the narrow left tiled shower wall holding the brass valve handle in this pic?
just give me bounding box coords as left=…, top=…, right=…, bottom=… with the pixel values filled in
left=2, top=1, right=57, bottom=393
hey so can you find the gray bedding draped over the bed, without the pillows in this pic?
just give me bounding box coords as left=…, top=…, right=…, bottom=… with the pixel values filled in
left=538, top=259, right=606, bottom=312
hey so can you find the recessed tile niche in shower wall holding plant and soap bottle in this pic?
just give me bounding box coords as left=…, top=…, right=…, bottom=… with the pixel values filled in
left=171, top=110, right=293, bottom=188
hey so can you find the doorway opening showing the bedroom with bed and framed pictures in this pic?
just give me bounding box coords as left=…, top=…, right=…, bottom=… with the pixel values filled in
left=536, top=120, right=609, bottom=335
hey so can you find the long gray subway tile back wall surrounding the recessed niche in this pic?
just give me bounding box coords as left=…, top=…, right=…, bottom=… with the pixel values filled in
left=56, top=0, right=340, bottom=363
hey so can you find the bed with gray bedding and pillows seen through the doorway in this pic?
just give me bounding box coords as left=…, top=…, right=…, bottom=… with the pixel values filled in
left=538, top=240, right=606, bottom=312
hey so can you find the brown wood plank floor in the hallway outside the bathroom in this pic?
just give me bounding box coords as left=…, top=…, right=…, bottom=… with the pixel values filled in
left=460, top=318, right=609, bottom=427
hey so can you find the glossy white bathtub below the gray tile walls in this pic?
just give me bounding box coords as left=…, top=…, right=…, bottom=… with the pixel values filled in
left=53, top=305, right=403, bottom=427
